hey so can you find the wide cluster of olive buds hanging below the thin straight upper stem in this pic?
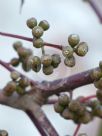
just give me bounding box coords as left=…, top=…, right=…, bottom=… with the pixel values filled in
left=10, top=41, right=61, bottom=75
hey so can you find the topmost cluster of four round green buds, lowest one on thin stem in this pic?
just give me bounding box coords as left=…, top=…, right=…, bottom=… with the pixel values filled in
left=26, top=18, right=50, bottom=48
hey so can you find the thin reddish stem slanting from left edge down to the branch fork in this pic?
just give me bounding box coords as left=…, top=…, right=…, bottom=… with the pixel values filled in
left=0, top=60, right=37, bottom=85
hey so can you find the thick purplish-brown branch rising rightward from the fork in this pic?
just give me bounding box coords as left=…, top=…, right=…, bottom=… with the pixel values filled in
left=36, top=68, right=98, bottom=96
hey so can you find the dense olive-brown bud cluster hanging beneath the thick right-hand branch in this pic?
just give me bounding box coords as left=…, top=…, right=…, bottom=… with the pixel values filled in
left=54, top=95, right=100, bottom=124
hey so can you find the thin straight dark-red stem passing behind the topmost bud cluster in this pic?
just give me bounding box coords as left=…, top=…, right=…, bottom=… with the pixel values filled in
left=0, top=32, right=62, bottom=50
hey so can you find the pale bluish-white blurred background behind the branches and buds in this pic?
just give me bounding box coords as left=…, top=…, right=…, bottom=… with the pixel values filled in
left=0, top=0, right=102, bottom=136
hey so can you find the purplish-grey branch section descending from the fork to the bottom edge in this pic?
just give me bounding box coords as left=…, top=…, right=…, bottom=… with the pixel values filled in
left=26, top=107, right=59, bottom=136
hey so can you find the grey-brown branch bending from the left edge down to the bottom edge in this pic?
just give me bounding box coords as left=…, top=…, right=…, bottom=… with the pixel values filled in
left=0, top=92, right=59, bottom=136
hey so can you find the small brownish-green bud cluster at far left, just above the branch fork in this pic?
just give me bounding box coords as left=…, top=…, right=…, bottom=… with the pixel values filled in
left=3, top=71, right=30, bottom=96
